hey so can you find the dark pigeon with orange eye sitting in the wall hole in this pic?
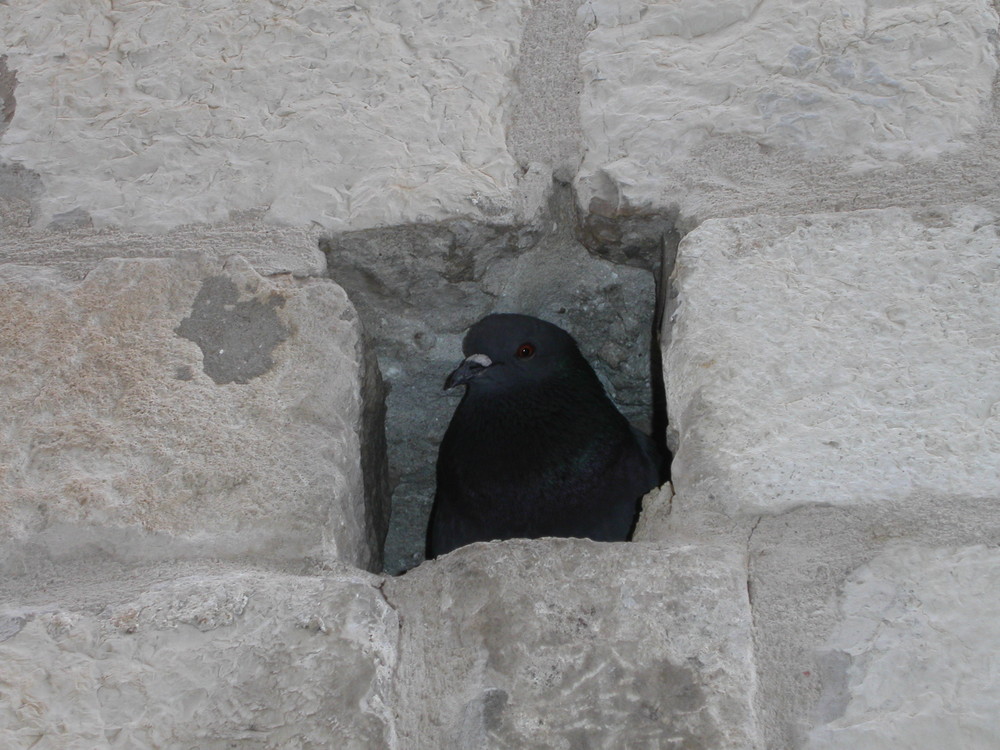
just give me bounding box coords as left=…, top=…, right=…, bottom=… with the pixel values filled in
left=427, top=313, right=660, bottom=558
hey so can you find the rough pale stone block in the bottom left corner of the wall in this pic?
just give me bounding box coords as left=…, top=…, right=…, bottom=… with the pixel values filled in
left=0, top=566, right=399, bottom=750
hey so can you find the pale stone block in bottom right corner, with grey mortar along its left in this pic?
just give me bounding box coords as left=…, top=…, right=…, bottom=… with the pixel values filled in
left=748, top=512, right=1000, bottom=750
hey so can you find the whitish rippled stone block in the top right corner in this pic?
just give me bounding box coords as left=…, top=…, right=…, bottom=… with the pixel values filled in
left=577, top=0, right=1000, bottom=228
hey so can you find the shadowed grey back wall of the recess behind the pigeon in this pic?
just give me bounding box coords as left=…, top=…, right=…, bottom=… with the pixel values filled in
left=323, top=188, right=655, bottom=573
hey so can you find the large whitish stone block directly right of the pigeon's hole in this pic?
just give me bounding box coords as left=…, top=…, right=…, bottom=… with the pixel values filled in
left=664, top=207, right=1000, bottom=531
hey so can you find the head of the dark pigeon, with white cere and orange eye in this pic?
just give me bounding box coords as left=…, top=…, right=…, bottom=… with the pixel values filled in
left=444, top=313, right=593, bottom=391
